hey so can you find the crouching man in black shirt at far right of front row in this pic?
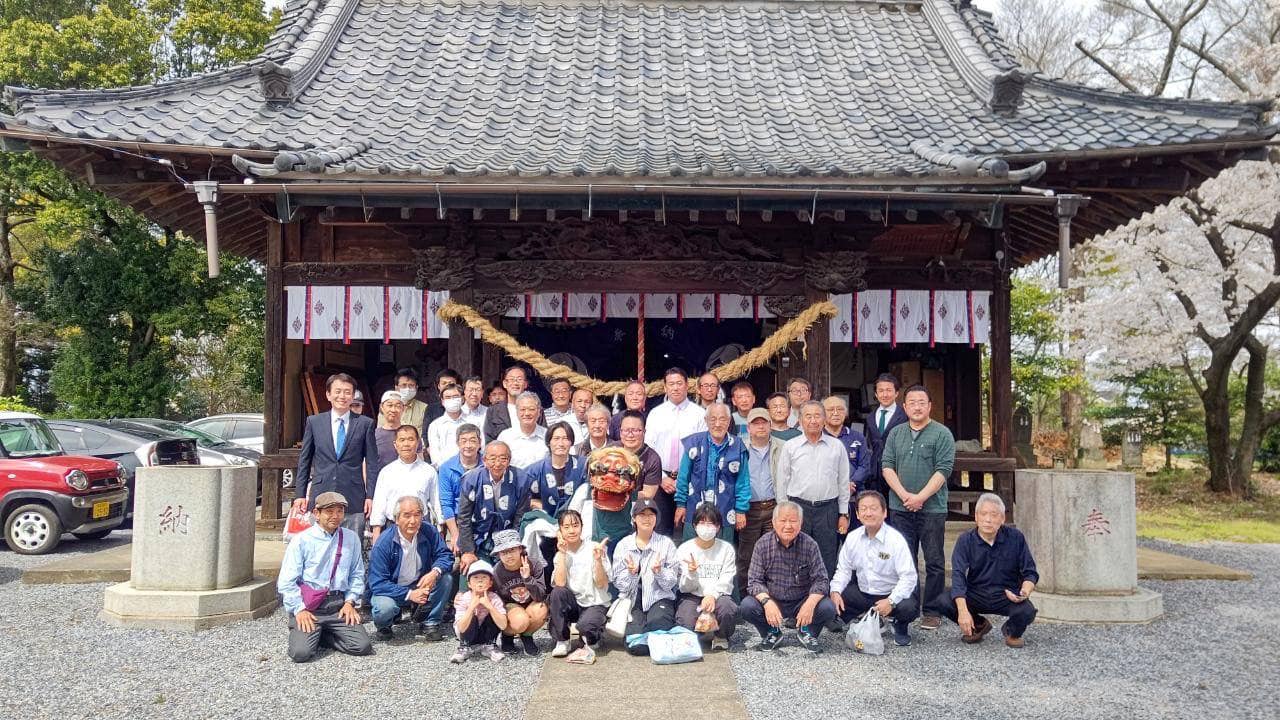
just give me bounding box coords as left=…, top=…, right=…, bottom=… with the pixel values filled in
left=942, top=492, right=1039, bottom=647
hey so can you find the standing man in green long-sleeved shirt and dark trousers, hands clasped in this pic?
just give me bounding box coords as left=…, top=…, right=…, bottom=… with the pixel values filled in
left=881, top=386, right=956, bottom=630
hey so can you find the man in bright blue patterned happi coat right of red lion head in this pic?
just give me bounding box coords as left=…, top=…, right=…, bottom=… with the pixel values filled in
left=676, top=402, right=751, bottom=544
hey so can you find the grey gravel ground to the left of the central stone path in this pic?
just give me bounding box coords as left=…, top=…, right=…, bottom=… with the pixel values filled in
left=0, top=536, right=550, bottom=720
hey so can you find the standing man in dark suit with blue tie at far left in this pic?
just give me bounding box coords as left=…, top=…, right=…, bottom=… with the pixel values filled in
left=293, top=373, right=381, bottom=533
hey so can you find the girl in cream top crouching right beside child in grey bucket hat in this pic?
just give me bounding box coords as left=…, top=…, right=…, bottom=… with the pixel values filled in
left=550, top=510, right=609, bottom=665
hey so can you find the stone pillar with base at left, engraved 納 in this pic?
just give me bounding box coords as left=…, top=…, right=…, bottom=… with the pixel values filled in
left=102, top=465, right=278, bottom=630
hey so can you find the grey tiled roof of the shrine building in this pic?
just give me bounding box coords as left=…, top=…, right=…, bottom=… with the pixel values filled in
left=0, top=0, right=1275, bottom=184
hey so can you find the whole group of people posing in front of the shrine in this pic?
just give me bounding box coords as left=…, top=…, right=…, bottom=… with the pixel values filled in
left=279, top=366, right=1038, bottom=664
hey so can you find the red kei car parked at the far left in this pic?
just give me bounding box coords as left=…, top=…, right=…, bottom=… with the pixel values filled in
left=0, top=413, right=129, bottom=555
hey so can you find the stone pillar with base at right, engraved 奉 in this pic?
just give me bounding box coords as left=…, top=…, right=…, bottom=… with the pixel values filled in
left=1016, top=469, right=1164, bottom=623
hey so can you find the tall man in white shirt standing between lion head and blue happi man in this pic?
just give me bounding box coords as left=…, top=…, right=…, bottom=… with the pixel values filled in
left=645, top=368, right=707, bottom=536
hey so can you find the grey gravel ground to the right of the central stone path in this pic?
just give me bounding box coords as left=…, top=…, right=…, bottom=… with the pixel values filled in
left=731, top=542, right=1280, bottom=720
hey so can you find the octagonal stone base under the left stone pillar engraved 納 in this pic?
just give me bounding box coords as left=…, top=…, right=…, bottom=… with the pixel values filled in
left=99, top=578, right=279, bottom=630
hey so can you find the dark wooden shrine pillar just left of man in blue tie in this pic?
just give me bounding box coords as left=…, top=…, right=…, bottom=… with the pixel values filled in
left=259, top=223, right=285, bottom=520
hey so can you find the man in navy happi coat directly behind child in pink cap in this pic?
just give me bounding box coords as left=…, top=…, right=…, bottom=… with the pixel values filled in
left=456, top=439, right=532, bottom=573
